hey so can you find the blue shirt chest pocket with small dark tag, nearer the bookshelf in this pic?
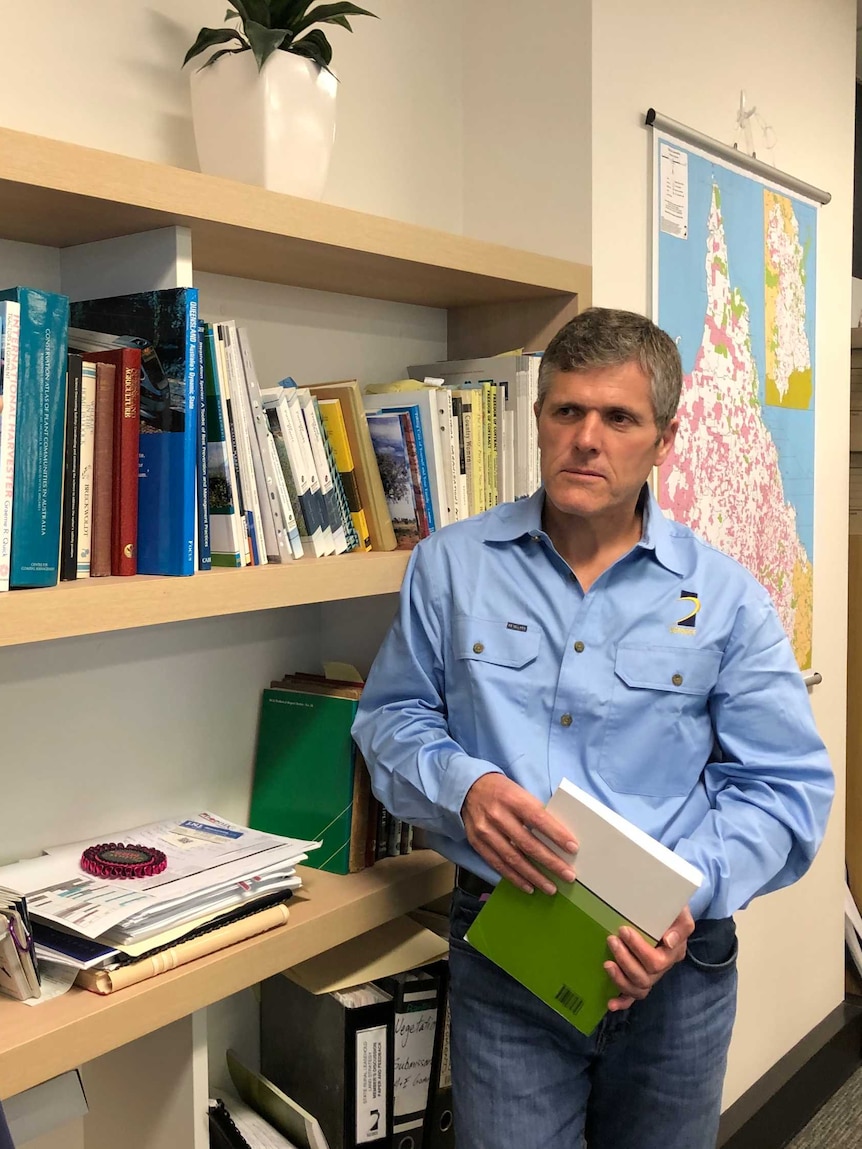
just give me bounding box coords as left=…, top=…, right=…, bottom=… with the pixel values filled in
left=452, top=615, right=541, bottom=712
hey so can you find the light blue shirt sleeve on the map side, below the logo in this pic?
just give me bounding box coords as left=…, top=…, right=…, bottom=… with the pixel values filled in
left=676, top=600, right=834, bottom=918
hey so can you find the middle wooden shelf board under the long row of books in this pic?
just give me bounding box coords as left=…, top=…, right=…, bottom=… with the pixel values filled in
left=0, top=550, right=409, bottom=647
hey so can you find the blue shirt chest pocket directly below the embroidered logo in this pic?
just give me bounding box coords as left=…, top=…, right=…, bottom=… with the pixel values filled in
left=599, top=646, right=722, bottom=797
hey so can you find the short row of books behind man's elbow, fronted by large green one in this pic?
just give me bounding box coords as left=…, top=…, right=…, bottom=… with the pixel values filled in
left=249, top=672, right=414, bottom=873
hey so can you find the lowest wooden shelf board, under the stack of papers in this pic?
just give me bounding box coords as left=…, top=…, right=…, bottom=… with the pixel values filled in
left=0, top=850, right=453, bottom=1098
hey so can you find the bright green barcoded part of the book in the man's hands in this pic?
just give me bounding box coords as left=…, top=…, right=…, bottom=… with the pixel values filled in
left=467, top=874, right=656, bottom=1035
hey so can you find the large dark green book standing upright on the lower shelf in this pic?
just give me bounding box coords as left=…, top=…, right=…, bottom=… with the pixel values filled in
left=248, top=689, right=356, bottom=873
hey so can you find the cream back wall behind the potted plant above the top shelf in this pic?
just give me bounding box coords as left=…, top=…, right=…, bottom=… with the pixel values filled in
left=0, top=0, right=462, bottom=231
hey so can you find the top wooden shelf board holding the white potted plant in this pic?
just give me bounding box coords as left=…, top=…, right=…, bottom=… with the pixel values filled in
left=0, top=128, right=591, bottom=308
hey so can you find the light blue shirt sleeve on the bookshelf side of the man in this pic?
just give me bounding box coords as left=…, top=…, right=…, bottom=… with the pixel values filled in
left=353, top=545, right=500, bottom=840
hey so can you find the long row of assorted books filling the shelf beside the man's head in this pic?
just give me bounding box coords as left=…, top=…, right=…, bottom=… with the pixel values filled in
left=0, top=280, right=547, bottom=589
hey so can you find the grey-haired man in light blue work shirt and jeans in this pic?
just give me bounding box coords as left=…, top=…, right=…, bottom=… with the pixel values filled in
left=354, top=308, right=833, bottom=1149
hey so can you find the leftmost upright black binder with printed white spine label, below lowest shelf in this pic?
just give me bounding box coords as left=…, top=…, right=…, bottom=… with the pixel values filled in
left=261, top=974, right=393, bottom=1149
